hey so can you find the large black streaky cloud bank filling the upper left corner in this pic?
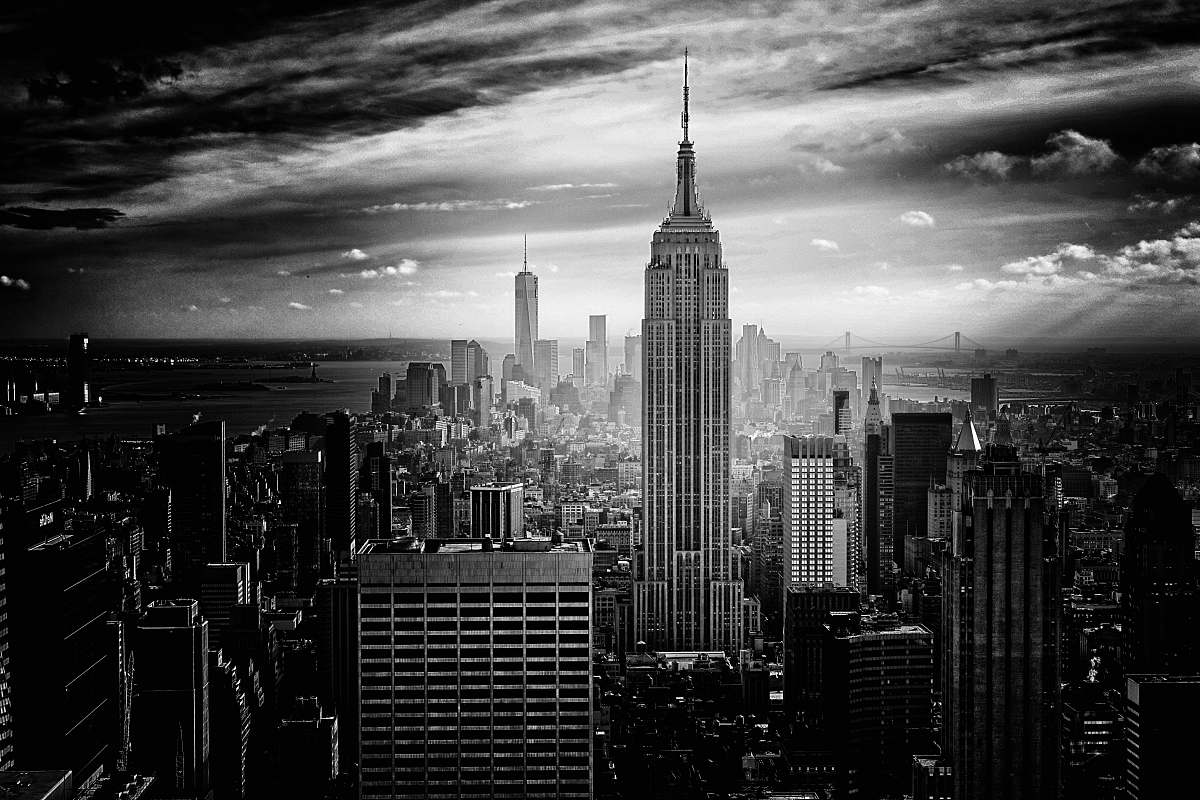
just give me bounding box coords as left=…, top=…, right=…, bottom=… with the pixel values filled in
left=0, top=2, right=654, bottom=200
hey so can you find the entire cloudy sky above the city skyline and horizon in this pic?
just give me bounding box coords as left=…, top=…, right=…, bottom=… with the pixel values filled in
left=0, top=0, right=1200, bottom=343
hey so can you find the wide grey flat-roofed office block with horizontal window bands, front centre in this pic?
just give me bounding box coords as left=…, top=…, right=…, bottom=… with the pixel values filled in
left=359, top=539, right=592, bottom=800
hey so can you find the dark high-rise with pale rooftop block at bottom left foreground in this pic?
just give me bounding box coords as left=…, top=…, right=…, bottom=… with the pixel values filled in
left=132, top=600, right=211, bottom=796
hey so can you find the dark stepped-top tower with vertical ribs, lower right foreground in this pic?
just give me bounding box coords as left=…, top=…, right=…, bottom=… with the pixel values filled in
left=941, top=464, right=1062, bottom=799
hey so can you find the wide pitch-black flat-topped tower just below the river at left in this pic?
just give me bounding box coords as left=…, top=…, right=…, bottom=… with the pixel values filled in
left=156, top=421, right=227, bottom=585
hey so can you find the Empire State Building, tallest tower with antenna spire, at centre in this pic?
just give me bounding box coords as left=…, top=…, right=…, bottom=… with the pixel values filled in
left=634, top=54, right=743, bottom=651
